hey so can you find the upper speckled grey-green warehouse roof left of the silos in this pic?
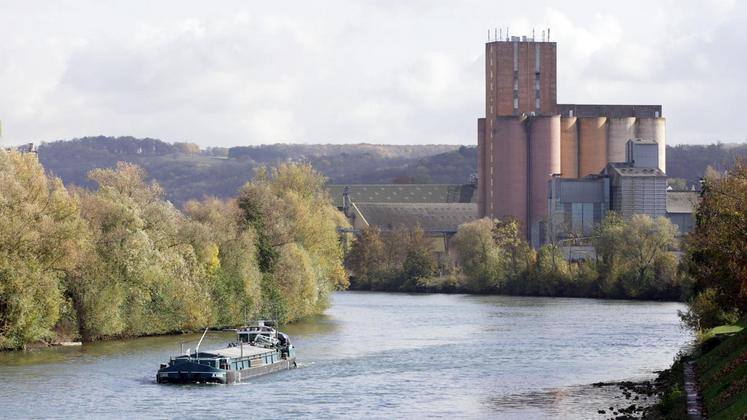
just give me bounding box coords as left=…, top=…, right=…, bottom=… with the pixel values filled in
left=326, top=184, right=475, bottom=207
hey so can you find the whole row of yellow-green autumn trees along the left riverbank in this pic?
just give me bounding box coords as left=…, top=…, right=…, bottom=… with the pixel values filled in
left=0, top=151, right=347, bottom=349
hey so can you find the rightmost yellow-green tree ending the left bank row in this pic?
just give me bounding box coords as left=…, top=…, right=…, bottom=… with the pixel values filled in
left=238, top=164, right=348, bottom=321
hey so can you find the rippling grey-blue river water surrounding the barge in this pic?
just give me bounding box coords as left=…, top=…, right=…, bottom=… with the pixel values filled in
left=0, top=292, right=692, bottom=419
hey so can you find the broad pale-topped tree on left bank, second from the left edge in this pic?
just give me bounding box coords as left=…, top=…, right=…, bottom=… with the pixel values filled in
left=68, top=163, right=211, bottom=340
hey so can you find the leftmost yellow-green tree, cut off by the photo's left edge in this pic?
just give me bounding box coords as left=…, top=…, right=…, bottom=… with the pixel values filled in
left=0, top=149, right=87, bottom=349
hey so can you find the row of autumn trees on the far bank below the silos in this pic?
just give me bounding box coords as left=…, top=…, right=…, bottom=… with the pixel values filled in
left=347, top=213, right=688, bottom=300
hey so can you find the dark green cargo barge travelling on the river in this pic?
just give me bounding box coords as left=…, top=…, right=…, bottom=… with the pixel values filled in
left=156, top=321, right=296, bottom=384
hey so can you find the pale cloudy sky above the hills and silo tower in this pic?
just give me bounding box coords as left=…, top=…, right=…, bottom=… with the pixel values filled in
left=0, top=0, right=747, bottom=147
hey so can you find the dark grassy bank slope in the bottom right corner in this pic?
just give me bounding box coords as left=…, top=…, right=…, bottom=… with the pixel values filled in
left=650, top=325, right=747, bottom=419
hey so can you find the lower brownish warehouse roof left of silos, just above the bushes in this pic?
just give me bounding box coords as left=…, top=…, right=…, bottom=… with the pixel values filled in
left=354, top=202, right=477, bottom=233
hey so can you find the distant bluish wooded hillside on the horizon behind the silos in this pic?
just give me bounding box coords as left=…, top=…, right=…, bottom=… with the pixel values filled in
left=39, top=136, right=747, bottom=206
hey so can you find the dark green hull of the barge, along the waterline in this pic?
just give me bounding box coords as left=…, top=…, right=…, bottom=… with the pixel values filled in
left=156, top=358, right=296, bottom=384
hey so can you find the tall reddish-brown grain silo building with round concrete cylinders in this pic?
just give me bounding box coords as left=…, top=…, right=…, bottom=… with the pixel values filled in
left=477, top=31, right=666, bottom=245
